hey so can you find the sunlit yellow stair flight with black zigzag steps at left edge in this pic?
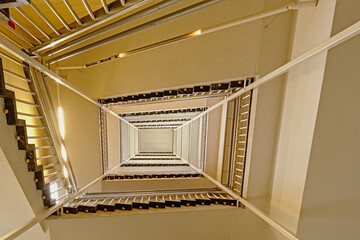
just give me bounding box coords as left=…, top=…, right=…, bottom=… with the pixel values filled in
left=0, top=53, right=71, bottom=210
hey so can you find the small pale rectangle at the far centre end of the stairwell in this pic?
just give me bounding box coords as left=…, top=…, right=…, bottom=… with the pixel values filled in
left=139, top=129, right=173, bottom=152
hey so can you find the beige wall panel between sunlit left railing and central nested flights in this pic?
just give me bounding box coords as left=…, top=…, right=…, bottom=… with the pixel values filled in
left=47, top=79, right=102, bottom=191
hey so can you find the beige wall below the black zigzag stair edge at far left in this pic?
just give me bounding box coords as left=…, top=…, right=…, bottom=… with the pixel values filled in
left=0, top=98, right=49, bottom=240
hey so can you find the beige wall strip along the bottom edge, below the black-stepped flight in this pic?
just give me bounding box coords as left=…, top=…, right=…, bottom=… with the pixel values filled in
left=47, top=206, right=262, bottom=240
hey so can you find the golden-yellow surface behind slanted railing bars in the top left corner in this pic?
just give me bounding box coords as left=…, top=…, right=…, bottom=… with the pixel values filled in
left=0, top=0, right=165, bottom=56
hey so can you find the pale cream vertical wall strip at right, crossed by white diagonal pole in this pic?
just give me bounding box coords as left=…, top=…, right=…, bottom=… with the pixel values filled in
left=269, top=0, right=336, bottom=237
